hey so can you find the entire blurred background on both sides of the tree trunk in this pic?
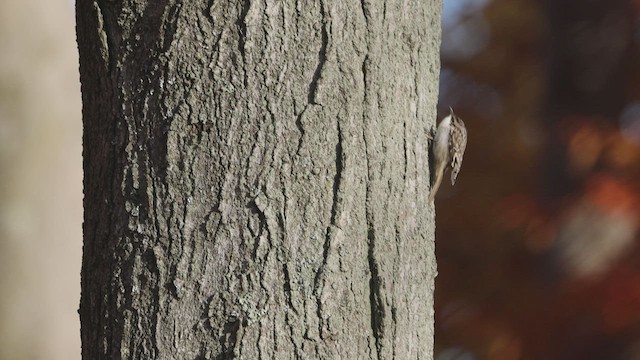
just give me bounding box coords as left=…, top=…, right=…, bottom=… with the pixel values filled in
left=0, top=0, right=640, bottom=360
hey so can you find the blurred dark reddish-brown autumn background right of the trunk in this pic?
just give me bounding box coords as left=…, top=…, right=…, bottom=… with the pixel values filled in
left=436, top=0, right=640, bottom=360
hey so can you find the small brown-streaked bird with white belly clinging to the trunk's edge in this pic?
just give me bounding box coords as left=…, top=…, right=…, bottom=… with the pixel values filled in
left=429, top=108, right=467, bottom=203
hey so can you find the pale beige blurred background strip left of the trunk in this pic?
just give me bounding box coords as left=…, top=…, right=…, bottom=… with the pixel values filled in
left=0, top=0, right=82, bottom=360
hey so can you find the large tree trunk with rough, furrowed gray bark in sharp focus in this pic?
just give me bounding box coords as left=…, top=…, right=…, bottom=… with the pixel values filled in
left=76, top=0, right=441, bottom=359
